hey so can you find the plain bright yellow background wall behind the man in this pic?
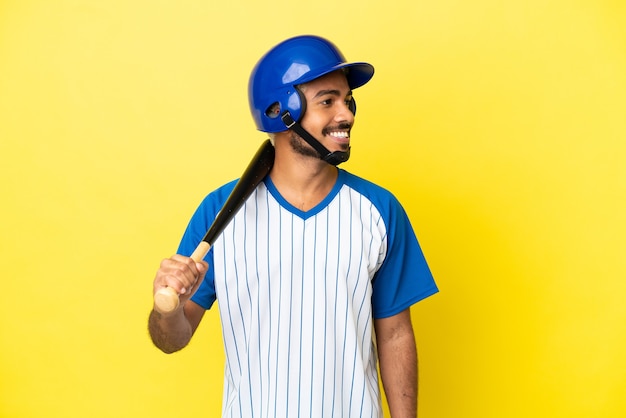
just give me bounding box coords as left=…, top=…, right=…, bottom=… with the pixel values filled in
left=0, top=0, right=626, bottom=418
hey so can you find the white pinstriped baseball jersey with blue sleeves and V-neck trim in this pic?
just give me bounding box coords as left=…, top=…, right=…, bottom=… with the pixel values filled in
left=179, top=170, right=437, bottom=418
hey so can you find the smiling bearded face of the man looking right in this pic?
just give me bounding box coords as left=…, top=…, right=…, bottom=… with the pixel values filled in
left=291, top=71, right=354, bottom=158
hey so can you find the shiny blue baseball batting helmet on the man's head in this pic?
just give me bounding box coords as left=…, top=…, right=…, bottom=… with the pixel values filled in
left=248, top=35, right=374, bottom=133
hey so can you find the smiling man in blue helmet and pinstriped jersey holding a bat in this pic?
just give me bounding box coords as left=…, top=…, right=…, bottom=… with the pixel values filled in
left=149, top=36, right=437, bottom=418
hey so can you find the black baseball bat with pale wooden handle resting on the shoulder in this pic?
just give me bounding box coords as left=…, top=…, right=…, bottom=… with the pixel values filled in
left=154, top=139, right=274, bottom=313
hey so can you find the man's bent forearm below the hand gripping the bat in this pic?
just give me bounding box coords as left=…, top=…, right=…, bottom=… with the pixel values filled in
left=148, top=307, right=193, bottom=354
